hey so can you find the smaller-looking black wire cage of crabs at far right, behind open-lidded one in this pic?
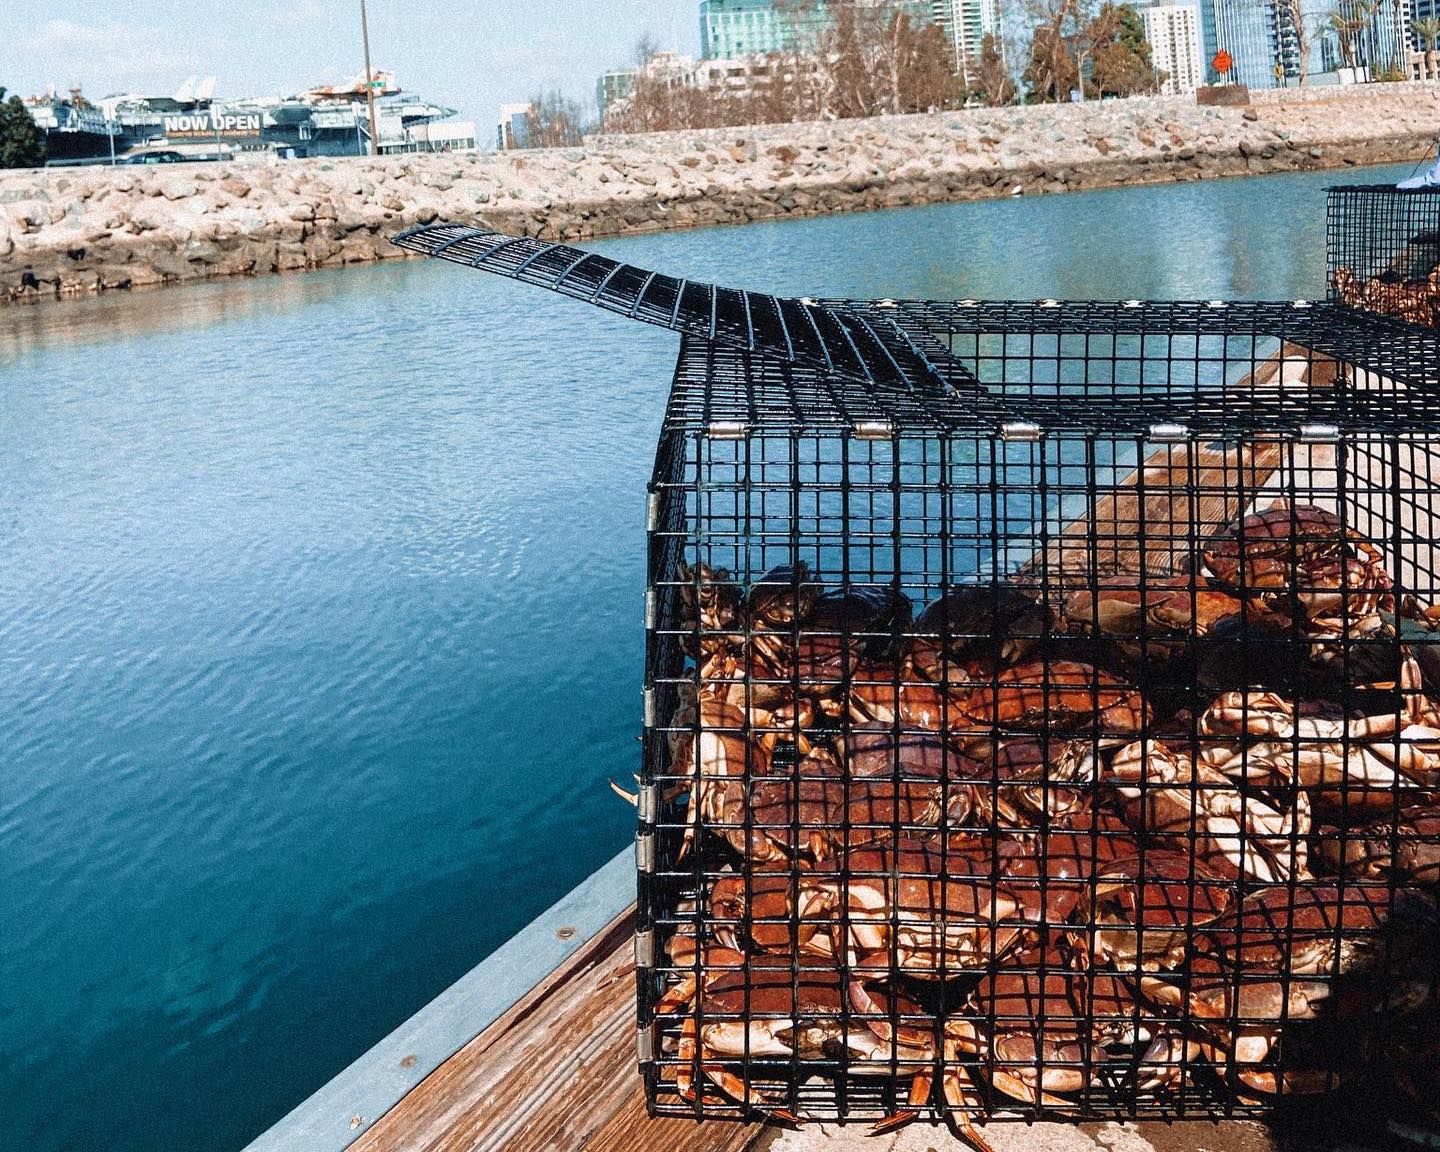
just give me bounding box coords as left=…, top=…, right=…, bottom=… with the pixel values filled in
left=1326, top=186, right=1440, bottom=328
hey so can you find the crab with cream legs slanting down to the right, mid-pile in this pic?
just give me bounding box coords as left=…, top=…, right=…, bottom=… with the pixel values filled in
left=1106, top=740, right=1310, bottom=884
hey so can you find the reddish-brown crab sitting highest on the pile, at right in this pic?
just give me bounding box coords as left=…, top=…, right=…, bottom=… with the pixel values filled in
left=1201, top=500, right=1395, bottom=660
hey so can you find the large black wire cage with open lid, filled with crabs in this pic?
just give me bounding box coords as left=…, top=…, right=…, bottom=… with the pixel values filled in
left=399, top=208, right=1440, bottom=1143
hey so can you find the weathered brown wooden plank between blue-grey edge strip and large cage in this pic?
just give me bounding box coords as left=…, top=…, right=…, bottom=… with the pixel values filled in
left=353, top=909, right=760, bottom=1152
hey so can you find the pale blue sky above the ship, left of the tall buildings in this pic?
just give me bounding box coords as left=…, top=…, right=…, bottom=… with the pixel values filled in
left=0, top=0, right=700, bottom=128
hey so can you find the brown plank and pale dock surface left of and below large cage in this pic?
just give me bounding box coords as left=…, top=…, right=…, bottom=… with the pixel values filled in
left=339, top=909, right=1405, bottom=1152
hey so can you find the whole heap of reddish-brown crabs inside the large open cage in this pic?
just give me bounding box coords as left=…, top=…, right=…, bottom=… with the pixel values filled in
left=657, top=503, right=1440, bottom=1145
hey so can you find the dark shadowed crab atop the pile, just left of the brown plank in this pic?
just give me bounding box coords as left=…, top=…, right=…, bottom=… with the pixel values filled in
left=910, top=583, right=1050, bottom=688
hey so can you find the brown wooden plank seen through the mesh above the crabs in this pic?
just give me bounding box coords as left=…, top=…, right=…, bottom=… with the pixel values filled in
left=1021, top=344, right=1341, bottom=576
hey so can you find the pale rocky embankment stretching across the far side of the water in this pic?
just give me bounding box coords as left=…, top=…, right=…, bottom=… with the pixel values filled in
left=0, top=84, right=1440, bottom=300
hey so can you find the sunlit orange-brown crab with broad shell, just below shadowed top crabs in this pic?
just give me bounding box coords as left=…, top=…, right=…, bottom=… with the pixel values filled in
left=956, top=660, right=1151, bottom=746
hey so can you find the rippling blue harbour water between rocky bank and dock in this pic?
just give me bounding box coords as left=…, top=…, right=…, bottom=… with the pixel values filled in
left=0, top=170, right=1405, bottom=1152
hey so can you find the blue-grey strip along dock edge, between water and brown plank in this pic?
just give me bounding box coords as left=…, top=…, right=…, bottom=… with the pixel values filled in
left=245, top=847, right=635, bottom=1152
